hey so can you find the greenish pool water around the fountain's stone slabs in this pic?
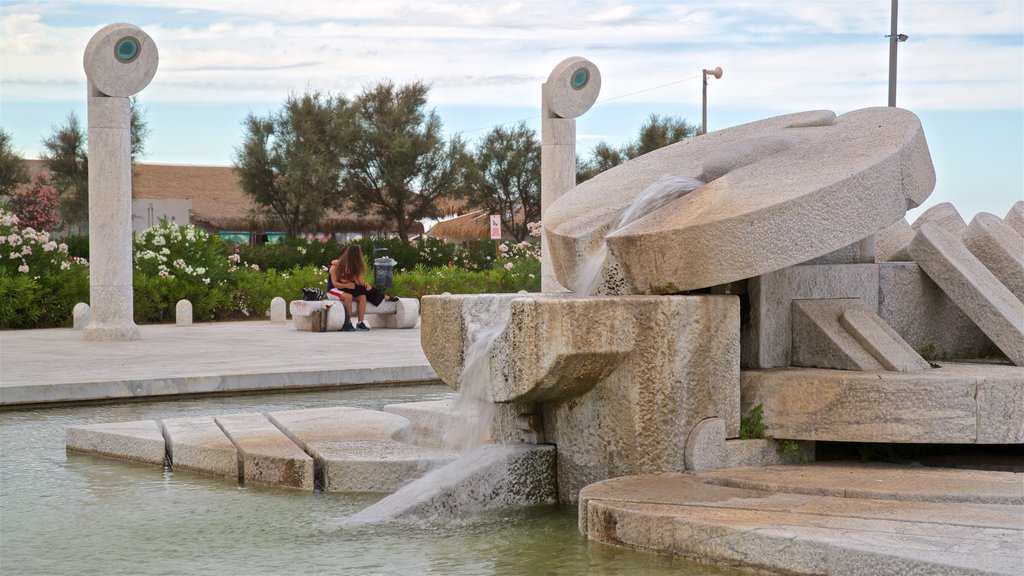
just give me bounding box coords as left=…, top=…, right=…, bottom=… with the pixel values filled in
left=0, top=386, right=736, bottom=576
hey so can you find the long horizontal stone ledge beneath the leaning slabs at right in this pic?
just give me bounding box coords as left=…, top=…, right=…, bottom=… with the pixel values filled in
left=740, top=363, right=1024, bottom=444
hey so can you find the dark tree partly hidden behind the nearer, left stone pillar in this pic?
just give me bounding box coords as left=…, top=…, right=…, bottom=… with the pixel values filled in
left=42, top=96, right=150, bottom=225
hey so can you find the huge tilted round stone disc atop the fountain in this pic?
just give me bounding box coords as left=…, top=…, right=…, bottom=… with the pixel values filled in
left=544, top=108, right=935, bottom=293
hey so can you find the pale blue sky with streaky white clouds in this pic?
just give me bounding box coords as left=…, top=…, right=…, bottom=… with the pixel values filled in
left=0, top=0, right=1024, bottom=221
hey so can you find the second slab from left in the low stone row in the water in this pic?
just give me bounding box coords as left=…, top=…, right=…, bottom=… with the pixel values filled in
left=161, top=416, right=241, bottom=480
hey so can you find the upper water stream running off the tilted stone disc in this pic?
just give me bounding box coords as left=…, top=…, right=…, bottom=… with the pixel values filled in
left=575, top=175, right=705, bottom=296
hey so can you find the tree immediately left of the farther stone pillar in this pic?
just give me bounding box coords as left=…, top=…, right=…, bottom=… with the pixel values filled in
left=467, top=122, right=541, bottom=242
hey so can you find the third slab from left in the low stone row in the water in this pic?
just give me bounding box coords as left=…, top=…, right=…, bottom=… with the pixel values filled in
left=215, top=414, right=313, bottom=491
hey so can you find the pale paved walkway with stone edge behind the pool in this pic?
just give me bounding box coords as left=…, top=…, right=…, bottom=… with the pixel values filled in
left=0, top=320, right=438, bottom=407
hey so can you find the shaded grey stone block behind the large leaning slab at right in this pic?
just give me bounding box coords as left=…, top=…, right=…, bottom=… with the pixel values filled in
left=879, top=262, right=998, bottom=360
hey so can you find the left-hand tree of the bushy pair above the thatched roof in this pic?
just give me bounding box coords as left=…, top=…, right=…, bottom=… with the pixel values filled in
left=234, top=91, right=350, bottom=238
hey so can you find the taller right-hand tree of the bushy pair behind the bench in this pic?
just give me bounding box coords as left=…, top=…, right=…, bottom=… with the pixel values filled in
left=345, top=81, right=470, bottom=242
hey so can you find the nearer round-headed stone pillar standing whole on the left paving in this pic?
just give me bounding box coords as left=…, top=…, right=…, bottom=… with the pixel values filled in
left=83, top=24, right=159, bottom=340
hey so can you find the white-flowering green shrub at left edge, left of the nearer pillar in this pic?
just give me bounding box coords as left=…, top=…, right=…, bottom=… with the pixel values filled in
left=0, top=209, right=89, bottom=328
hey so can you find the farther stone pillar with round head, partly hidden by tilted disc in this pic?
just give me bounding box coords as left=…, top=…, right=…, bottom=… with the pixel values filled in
left=541, top=56, right=601, bottom=293
